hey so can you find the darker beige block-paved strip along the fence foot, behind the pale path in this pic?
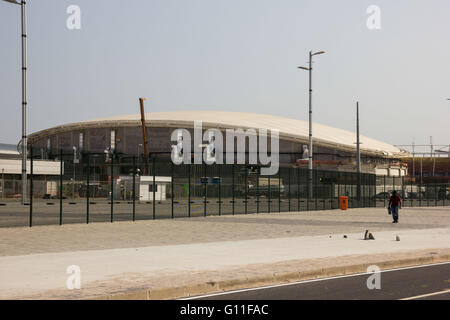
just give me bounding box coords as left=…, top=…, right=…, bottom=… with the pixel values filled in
left=0, top=207, right=450, bottom=256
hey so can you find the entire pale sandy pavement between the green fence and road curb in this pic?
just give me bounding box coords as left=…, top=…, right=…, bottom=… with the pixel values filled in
left=0, top=207, right=450, bottom=298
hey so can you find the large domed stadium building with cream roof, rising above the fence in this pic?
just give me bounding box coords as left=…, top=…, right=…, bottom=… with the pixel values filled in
left=29, top=111, right=407, bottom=176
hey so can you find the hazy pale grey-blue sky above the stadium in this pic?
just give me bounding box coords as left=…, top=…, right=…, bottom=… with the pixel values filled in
left=0, top=0, right=450, bottom=150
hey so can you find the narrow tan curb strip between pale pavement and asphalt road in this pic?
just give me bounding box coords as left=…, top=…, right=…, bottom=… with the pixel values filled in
left=93, top=254, right=450, bottom=300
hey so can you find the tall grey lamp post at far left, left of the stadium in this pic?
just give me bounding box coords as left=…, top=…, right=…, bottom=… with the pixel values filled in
left=3, top=0, right=27, bottom=204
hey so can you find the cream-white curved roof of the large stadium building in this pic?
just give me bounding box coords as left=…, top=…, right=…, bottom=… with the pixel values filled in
left=30, top=111, right=401, bottom=156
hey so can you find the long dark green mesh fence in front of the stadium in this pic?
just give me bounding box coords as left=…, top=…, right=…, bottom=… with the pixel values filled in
left=0, top=152, right=450, bottom=227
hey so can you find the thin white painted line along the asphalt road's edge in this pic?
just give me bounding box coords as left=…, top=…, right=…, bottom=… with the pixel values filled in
left=178, top=261, right=450, bottom=300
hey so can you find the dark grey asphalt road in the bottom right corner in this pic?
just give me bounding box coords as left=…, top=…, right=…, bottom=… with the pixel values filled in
left=186, top=262, right=450, bottom=300
